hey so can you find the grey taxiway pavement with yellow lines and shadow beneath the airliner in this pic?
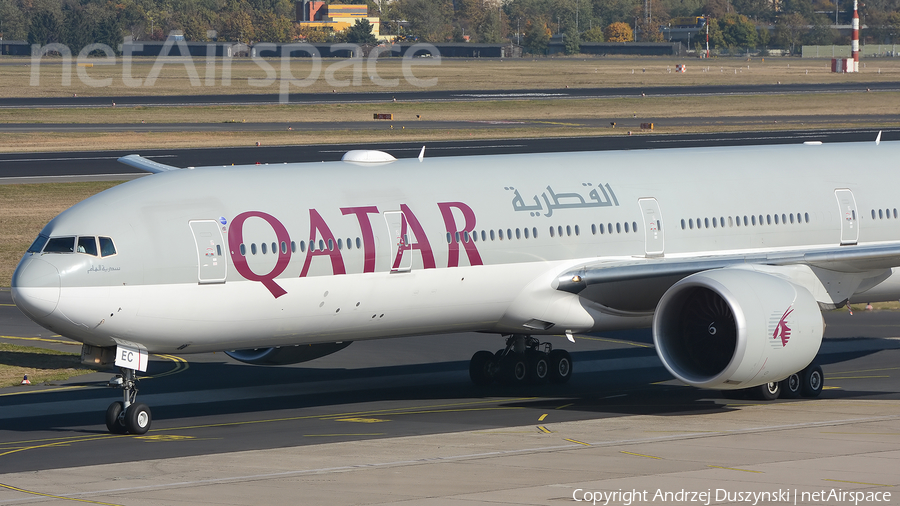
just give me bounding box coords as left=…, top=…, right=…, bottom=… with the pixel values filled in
left=0, top=284, right=900, bottom=505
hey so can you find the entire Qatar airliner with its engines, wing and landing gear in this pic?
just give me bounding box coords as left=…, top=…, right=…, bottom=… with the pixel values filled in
left=12, top=138, right=900, bottom=434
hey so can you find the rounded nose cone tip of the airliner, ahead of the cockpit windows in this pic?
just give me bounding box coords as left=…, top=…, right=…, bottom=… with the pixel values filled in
left=11, top=257, right=59, bottom=318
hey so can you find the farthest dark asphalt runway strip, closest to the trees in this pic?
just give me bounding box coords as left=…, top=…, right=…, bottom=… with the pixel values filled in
left=0, top=82, right=900, bottom=108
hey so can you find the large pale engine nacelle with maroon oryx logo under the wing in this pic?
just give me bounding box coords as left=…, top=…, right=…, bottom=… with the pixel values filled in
left=653, top=268, right=825, bottom=390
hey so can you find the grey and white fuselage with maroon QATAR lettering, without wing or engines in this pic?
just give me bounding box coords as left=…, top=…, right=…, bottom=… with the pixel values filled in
left=13, top=143, right=900, bottom=353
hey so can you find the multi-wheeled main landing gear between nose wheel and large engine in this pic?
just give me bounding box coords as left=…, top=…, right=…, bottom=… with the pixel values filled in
left=469, top=334, right=572, bottom=385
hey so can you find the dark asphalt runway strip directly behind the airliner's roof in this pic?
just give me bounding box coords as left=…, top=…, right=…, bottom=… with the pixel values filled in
left=0, top=128, right=900, bottom=184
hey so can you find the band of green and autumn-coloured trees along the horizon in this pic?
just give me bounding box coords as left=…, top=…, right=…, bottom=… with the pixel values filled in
left=0, top=0, right=900, bottom=54
